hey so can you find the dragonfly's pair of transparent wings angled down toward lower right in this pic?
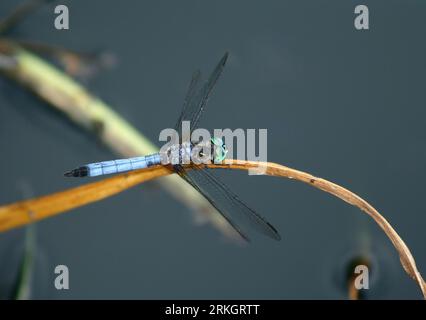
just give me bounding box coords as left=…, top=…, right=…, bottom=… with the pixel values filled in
left=175, top=165, right=281, bottom=241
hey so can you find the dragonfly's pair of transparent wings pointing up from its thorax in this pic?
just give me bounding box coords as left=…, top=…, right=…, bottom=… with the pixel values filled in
left=175, top=53, right=228, bottom=132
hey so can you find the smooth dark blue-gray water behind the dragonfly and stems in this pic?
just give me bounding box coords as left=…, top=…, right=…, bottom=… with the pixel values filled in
left=0, top=0, right=426, bottom=299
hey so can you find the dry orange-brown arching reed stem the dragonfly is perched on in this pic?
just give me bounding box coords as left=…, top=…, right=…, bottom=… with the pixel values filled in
left=0, top=160, right=426, bottom=299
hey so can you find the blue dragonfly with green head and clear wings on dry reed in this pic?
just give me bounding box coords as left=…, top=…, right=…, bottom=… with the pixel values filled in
left=64, top=52, right=281, bottom=241
